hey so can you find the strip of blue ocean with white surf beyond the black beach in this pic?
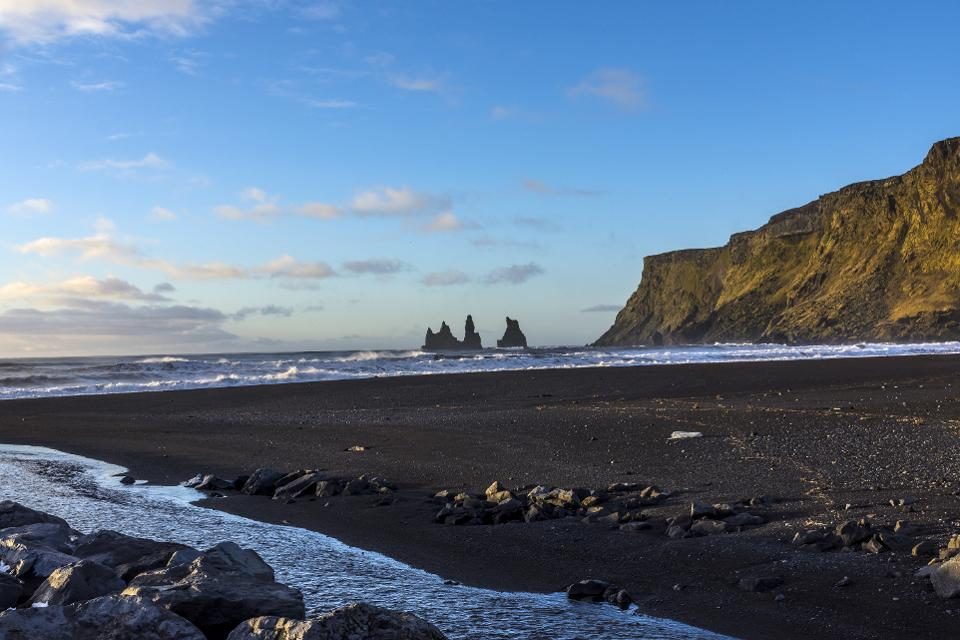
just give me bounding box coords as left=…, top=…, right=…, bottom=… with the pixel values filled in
left=0, top=342, right=960, bottom=399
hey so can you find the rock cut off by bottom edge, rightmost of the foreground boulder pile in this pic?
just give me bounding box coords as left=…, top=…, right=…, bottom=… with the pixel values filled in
left=227, top=603, right=446, bottom=640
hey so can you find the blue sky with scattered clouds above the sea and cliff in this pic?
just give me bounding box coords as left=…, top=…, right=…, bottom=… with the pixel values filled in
left=0, top=0, right=960, bottom=356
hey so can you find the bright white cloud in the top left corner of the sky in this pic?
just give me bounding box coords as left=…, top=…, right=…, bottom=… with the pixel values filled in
left=0, top=0, right=210, bottom=45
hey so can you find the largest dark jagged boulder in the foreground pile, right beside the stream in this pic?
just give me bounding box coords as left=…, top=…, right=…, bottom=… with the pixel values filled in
left=123, top=542, right=304, bottom=637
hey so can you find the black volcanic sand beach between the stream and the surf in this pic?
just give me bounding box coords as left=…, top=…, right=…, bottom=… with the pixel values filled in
left=0, top=356, right=960, bottom=639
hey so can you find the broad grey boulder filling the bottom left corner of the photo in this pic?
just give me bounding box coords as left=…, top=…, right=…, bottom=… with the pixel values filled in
left=0, top=596, right=206, bottom=640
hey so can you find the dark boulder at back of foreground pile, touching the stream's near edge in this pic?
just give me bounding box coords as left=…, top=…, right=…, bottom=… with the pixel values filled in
left=73, top=529, right=188, bottom=580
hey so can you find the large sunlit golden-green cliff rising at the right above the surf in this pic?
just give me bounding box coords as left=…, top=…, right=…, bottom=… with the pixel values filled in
left=596, top=138, right=960, bottom=346
